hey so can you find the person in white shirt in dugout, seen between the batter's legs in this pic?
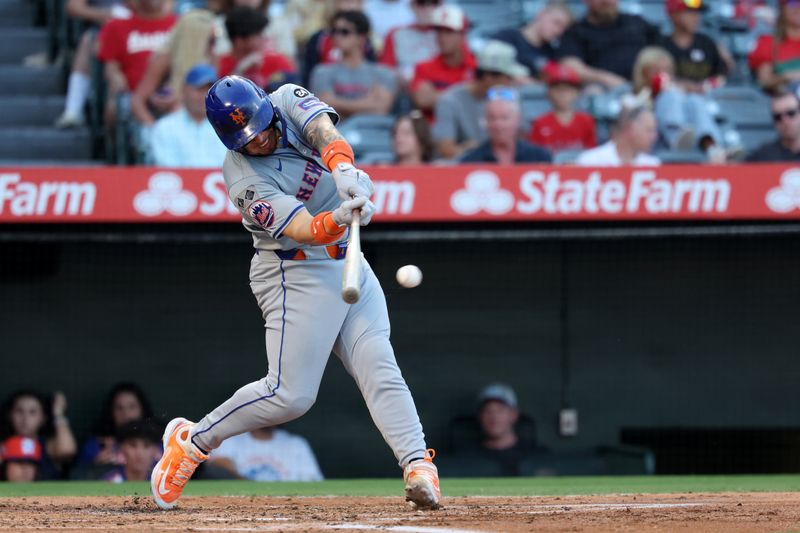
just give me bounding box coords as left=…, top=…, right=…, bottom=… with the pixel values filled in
left=209, top=428, right=323, bottom=481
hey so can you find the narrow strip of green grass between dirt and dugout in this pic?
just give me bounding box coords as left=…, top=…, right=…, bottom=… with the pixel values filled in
left=0, top=475, right=800, bottom=497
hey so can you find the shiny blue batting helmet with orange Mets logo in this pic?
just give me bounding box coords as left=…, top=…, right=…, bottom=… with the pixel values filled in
left=206, top=76, right=275, bottom=150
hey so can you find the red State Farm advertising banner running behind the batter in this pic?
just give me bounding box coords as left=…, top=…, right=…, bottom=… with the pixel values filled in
left=0, top=165, right=800, bottom=222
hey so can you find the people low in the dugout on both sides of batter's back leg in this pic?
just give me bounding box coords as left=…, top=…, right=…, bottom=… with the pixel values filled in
left=0, top=383, right=323, bottom=483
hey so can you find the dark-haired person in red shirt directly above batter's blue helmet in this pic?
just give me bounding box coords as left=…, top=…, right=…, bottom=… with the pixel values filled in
left=218, top=6, right=298, bottom=92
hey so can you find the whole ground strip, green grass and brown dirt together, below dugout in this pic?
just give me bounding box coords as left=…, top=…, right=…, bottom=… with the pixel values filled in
left=0, top=475, right=800, bottom=533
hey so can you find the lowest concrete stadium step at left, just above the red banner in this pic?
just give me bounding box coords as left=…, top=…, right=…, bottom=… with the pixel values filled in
left=0, top=127, right=92, bottom=161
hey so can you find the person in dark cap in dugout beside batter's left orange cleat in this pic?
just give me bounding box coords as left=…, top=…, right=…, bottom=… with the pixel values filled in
left=102, top=419, right=163, bottom=483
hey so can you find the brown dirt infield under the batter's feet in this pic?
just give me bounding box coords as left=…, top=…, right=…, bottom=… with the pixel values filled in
left=0, top=493, right=800, bottom=533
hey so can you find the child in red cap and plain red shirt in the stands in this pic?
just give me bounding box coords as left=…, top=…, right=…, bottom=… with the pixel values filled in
left=528, top=63, right=597, bottom=153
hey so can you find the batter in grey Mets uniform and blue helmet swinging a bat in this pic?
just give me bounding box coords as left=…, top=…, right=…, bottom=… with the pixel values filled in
left=150, top=76, right=440, bottom=509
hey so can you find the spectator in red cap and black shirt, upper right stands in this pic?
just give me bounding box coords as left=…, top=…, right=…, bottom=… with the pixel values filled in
left=661, top=0, right=733, bottom=93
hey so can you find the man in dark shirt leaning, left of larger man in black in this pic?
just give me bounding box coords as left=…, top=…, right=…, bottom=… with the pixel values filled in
left=492, top=0, right=572, bottom=78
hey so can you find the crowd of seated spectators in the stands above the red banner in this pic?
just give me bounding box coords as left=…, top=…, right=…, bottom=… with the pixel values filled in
left=51, top=0, right=800, bottom=167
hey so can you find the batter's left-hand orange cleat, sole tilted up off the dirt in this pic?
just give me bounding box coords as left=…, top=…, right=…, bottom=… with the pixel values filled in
left=150, top=418, right=208, bottom=509
